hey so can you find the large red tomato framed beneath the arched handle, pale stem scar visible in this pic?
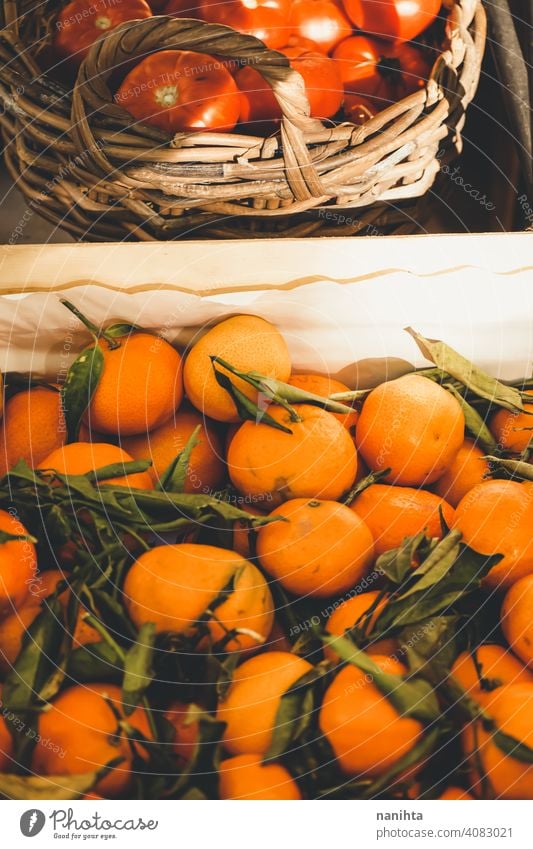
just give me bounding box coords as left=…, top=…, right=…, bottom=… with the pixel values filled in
left=115, top=50, right=241, bottom=133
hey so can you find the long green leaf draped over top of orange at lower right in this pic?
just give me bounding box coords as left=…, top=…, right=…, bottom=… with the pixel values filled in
left=322, top=635, right=440, bottom=724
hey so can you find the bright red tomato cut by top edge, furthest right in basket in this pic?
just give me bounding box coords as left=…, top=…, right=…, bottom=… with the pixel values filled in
left=343, top=0, right=441, bottom=41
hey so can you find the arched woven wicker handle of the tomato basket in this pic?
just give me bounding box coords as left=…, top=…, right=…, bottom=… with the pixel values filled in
left=70, top=15, right=327, bottom=201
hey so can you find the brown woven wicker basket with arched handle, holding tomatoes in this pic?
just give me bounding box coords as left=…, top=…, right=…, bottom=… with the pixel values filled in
left=0, top=0, right=485, bottom=241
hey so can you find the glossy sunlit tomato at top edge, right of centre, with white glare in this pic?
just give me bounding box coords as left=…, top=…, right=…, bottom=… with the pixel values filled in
left=290, top=0, right=352, bottom=53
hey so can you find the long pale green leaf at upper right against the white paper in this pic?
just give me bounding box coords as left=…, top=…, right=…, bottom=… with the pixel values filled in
left=405, top=327, right=523, bottom=412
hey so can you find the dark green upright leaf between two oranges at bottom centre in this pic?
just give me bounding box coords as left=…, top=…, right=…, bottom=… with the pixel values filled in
left=263, top=665, right=326, bottom=763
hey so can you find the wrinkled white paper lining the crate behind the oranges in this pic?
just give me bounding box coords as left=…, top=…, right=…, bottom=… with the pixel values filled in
left=0, top=268, right=533, bottom=388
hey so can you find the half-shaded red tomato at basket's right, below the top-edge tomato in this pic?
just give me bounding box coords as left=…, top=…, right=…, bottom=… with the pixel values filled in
left=333, top=35, right=431, bottom=110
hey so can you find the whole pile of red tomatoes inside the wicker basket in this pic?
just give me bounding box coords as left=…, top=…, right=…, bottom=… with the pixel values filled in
left=54, top=0, right=441, bottom=134
